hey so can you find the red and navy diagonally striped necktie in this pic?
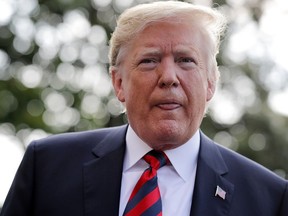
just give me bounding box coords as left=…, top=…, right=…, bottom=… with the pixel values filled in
left=123, top=150, right=169, bottom=216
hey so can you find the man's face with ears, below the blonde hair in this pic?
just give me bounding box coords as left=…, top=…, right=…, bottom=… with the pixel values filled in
left=112, top=22, right=215, bottom=150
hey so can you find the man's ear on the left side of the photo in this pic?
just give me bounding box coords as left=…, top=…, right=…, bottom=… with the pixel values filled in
left=110, top=66, right=125, bottom=103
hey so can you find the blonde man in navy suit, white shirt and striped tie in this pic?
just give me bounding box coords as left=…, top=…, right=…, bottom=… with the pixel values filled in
left=1, top=2, right=288, bottom=216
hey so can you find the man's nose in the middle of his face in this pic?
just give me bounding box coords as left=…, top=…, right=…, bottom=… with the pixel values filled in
left=158, top=62, right=180, bottom=88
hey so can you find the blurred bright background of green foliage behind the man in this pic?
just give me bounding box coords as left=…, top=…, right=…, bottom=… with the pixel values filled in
left=0, top=0, right=288, bottom=207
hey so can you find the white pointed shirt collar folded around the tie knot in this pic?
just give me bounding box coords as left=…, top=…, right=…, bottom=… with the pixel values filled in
left=123, top=125, right=200, bottom=181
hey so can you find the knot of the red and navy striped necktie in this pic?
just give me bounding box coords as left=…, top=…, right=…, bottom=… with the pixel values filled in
left=144, top=150, right=169, bottom=170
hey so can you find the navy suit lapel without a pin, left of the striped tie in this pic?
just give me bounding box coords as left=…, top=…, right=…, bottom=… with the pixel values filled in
left=83, top=127, right=126, bottom=216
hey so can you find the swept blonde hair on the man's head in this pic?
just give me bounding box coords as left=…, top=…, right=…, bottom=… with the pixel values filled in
left=109, top=1, right=226, bottom=80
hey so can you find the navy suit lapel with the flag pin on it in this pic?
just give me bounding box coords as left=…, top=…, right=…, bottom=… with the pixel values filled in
left=190, top=134, right=234, bottom=216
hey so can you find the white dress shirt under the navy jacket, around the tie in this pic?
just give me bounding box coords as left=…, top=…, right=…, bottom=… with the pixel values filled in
left=119, top=126, right=200, bottom=216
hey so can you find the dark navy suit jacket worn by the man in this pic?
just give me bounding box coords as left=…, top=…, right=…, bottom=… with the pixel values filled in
left=1, top=126, right=288, bottom=216
